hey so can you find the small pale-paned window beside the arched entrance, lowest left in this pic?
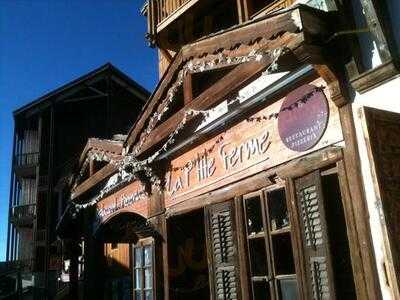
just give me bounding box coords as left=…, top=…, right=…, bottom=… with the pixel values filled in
left=132, top=240, right=154, bottom=300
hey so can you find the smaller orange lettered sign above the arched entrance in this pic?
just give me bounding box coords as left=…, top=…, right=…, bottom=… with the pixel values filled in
left=96, top=181, right=149, bottom=224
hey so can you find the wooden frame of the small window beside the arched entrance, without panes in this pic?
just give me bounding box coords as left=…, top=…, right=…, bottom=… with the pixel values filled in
left=130, top=238, right=156, bottom=300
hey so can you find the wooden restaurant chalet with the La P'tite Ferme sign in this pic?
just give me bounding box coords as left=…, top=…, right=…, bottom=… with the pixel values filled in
left=58, top=0, right=400, bottom=300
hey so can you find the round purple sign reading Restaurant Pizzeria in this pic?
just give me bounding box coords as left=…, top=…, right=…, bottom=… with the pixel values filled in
left=278, top=84, right=329, bottom=152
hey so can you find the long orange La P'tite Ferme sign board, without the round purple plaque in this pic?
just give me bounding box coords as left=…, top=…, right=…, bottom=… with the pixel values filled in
left=165, top=79, right=343, bottom=208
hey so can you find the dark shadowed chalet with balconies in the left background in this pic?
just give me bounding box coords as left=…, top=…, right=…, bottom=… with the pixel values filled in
left=7, top=64, right=149, bottom=299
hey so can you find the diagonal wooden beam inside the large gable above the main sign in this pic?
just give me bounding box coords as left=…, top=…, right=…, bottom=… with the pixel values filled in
left=139, top=60, right=271, bottom=155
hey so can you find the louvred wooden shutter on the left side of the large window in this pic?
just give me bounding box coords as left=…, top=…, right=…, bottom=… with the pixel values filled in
left=205, top=201, right=240, bottom=300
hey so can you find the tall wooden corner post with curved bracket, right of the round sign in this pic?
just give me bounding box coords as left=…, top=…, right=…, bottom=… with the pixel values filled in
left=314, top=65, right=382, bottom=299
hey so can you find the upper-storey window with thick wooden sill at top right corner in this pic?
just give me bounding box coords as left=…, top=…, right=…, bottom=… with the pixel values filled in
left=344, top=0, right=400, bottom=93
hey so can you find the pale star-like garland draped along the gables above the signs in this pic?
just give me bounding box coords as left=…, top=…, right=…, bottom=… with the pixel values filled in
left=72, top=47, right=324, bottom=216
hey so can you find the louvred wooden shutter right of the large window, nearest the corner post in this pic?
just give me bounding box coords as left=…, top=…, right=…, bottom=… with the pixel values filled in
left=295, top=171, right=335, bottom=300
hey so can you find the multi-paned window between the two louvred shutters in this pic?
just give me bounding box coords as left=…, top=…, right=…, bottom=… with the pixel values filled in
left=243, top=187, right=298, bottom=300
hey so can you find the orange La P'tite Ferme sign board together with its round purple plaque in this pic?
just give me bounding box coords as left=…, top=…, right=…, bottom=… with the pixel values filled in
left=165, top=79, right=343, bottom=207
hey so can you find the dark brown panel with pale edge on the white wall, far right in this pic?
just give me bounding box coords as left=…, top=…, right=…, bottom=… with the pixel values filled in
left=363, top=107, right=400, bottom=299
